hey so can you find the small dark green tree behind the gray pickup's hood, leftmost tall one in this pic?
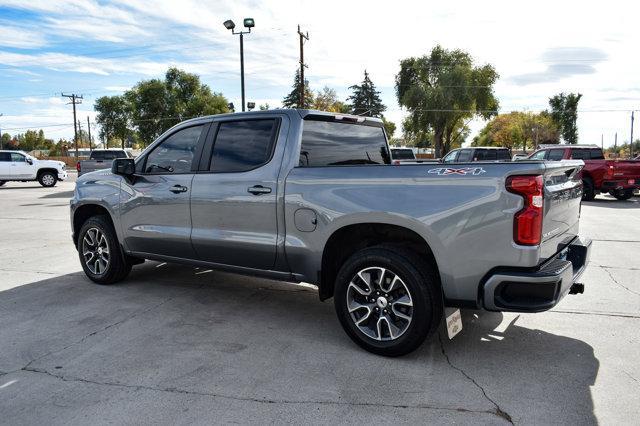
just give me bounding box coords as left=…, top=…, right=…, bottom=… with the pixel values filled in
left=94, top=96, right=132, bottom=149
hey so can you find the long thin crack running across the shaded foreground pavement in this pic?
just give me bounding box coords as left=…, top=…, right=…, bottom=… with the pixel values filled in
left=16, top=367, right=500, bottom=421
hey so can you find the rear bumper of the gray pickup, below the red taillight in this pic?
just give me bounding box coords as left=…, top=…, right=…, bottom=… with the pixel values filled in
left=482, top=237, right=591, bottom=312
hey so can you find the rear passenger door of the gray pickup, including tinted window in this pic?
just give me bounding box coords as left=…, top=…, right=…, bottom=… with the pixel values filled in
left=191, top=118, right=286, bottom=269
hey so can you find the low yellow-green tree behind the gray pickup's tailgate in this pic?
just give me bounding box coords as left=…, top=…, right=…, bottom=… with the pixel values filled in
left=472, top=111, right=560, bottom=149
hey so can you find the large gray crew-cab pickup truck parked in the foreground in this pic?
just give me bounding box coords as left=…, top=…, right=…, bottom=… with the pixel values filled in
left=71, top=110, right=591, bottom=356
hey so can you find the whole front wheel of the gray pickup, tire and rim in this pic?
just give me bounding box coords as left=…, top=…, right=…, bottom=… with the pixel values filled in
left=78, top=216, right=131, bottom=284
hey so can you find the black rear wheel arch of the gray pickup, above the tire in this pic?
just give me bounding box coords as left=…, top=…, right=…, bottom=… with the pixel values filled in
left=318, top=222, right=441, bottom=300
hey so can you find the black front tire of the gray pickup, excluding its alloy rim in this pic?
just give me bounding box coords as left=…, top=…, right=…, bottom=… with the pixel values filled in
left=78, top=215, right=132, bottom=284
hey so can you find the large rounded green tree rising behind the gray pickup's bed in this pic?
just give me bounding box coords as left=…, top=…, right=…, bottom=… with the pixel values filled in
left=396, top=46, right=498, bottom=157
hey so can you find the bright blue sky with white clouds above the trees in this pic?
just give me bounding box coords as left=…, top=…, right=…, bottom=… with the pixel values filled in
left=0, top=0, right=640, bottom=146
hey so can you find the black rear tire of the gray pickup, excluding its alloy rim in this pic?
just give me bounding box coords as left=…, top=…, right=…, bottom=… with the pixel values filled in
left=333, top=245, right=443, bottom=356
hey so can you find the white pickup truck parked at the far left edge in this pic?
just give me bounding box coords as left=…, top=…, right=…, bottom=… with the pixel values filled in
left=0, top=150, right=67, bottom=188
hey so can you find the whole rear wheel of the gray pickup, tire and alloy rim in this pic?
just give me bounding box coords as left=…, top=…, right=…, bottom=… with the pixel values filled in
left=334, top=246, right=443, bottom=356
